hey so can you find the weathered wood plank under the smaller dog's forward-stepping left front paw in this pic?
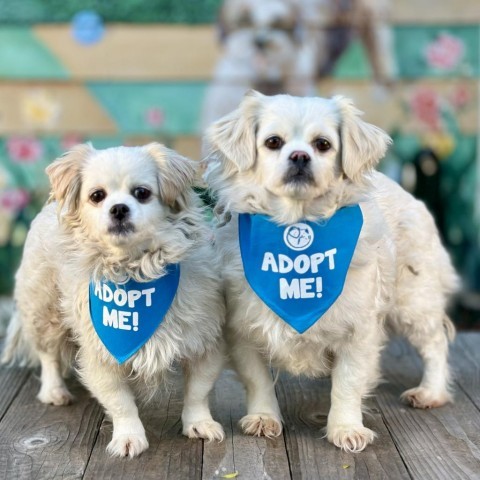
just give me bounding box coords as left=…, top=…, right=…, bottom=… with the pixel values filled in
left=84, top=375, right=203, bottom=480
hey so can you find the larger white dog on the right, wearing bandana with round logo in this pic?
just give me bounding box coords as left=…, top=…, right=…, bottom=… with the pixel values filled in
left=202, top=92, right=457, bottom=452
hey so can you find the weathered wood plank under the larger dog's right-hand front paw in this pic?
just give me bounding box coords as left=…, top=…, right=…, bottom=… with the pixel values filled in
left=277, top=374, right=410, bottom=480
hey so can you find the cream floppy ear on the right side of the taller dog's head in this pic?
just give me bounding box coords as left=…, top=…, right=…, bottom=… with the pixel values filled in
left=333, top=95, right=392, bottom=181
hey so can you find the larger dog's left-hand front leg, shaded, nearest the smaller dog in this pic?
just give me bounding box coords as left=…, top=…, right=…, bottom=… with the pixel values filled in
left=231, top=340, right=282, bottom=437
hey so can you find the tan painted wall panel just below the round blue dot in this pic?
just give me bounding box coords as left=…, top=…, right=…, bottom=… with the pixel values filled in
left=34, top=24, right=219, bottom=81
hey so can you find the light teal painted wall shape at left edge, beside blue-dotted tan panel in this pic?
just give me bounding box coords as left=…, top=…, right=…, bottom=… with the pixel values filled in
left=0, top=27, right=69, bottom=79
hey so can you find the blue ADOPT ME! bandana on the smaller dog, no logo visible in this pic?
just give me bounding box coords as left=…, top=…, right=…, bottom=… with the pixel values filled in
left=89, top=264, right=180, bottom=364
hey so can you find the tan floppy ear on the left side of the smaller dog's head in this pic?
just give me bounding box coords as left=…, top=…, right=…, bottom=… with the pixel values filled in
left=45, top=143, right=95, bottom=213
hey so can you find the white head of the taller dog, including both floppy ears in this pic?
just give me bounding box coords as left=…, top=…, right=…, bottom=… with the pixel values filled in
left=207, top=92, right=390, bottom=207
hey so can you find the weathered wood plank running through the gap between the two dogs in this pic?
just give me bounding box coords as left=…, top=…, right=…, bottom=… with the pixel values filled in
left=202, top=371, right=290, bottom=480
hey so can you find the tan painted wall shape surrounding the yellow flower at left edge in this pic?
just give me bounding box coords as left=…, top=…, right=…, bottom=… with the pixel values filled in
left=0, top=82, right=117, bottom=135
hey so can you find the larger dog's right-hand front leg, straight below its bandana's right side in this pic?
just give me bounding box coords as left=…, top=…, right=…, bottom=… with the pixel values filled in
left=327, top=340, right=380, bottom=452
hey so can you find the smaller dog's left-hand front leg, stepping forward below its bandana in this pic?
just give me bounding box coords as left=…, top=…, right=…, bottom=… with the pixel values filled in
left=80, top=355, right=148, bottom=458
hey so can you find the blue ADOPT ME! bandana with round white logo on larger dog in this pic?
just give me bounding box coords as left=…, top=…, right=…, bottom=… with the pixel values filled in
left=238, top=205, right=363, bottom=333
